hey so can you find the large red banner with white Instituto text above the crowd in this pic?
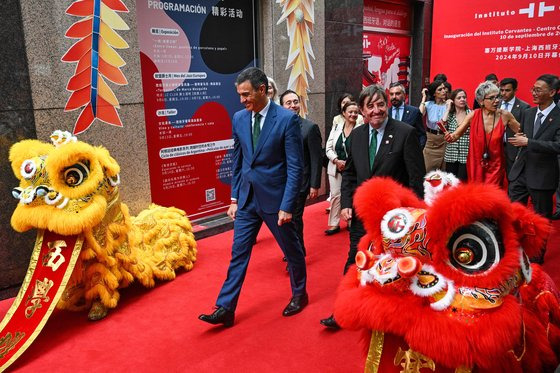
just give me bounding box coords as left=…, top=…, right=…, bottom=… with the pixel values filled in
left=431, top=0, right=560, bottom=103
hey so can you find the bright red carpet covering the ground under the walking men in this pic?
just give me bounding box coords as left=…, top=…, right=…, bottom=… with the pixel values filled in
left=0, top=202, right=560, bottom=373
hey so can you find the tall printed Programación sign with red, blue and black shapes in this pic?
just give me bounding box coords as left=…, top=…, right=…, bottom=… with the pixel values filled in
left=136, top=0, right=256, bottom=219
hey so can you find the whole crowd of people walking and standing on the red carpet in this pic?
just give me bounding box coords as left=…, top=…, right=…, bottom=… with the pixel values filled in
left=199, top=68, right=560, bottom=328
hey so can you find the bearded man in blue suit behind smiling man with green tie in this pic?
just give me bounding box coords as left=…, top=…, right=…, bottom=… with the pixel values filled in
left=389, top=82, right=426, bottom=149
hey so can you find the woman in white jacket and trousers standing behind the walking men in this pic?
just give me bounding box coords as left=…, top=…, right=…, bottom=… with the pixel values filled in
left=325, top=101, right=363, bottom=236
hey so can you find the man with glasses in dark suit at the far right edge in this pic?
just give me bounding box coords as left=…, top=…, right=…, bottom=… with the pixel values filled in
left=508, top=74, right=560, bottom=218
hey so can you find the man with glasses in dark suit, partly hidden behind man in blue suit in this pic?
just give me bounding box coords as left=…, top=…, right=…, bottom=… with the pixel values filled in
left=280, top=90, right=323, bottom=253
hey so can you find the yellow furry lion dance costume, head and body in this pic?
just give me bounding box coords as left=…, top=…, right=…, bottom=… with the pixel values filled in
left=10, top=131, right=197, bottom=320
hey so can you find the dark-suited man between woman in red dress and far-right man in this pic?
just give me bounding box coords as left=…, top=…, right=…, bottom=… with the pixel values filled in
left=500, top=78, right=531, bottom=175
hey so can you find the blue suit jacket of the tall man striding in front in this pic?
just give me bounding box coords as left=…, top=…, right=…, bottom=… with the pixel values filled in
left=231, top=102, right=303, bottom=214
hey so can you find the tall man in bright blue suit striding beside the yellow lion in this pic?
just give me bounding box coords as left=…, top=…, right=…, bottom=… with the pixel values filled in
left=199, top=67, right=308, bottom=327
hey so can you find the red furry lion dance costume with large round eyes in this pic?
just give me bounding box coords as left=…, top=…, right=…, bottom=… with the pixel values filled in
left=334, top=173, right=560, bottom=373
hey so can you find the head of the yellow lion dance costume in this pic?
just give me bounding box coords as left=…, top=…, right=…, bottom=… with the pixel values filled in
left=10, top=131, right=120, bottom=235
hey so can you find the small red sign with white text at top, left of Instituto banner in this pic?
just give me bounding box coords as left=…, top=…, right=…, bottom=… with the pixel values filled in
left=364, top=0, right=411, bottom=35
